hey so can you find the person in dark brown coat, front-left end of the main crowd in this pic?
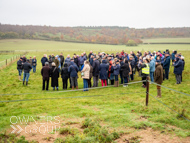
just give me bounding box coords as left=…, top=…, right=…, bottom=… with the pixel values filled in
left=41, top=62, right=50, bottom=90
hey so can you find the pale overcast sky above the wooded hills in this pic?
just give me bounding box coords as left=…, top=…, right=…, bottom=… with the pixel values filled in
left=0, top=0, right=190, bottom=28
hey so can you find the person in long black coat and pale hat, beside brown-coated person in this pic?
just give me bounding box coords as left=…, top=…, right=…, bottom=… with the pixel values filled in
left=50, top=62, right=59, bottom=90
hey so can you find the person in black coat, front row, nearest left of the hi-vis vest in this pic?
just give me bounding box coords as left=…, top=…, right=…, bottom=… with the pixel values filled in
left=121, top=59, right=130, bottom=87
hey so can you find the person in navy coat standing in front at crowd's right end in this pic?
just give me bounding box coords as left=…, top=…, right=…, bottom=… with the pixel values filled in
left=173, top=57, right=183, bottom=84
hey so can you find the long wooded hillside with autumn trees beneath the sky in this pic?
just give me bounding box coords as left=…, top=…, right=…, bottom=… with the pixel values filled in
left=0, top=24, right=190, bottom=46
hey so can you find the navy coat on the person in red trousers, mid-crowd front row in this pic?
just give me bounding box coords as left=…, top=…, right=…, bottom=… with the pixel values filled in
left=99, top=60, right=109, bottom=79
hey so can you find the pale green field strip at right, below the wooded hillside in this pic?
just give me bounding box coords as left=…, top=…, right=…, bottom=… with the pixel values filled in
left=142, top=38, right=190, bottom=43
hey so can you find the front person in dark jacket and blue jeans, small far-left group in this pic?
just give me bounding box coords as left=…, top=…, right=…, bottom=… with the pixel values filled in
left=22, top=60, right=32, bottom=86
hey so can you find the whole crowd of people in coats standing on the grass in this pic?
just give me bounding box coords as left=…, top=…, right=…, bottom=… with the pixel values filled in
left=17, top=50, right=185, bottom=97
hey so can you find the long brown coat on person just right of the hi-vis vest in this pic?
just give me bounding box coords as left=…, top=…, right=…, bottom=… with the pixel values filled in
left=154, top=64, right=163, bottom=84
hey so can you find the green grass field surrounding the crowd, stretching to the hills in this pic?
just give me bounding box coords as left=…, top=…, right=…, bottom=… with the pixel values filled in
left=0, top=40, right=190, bottom=142
